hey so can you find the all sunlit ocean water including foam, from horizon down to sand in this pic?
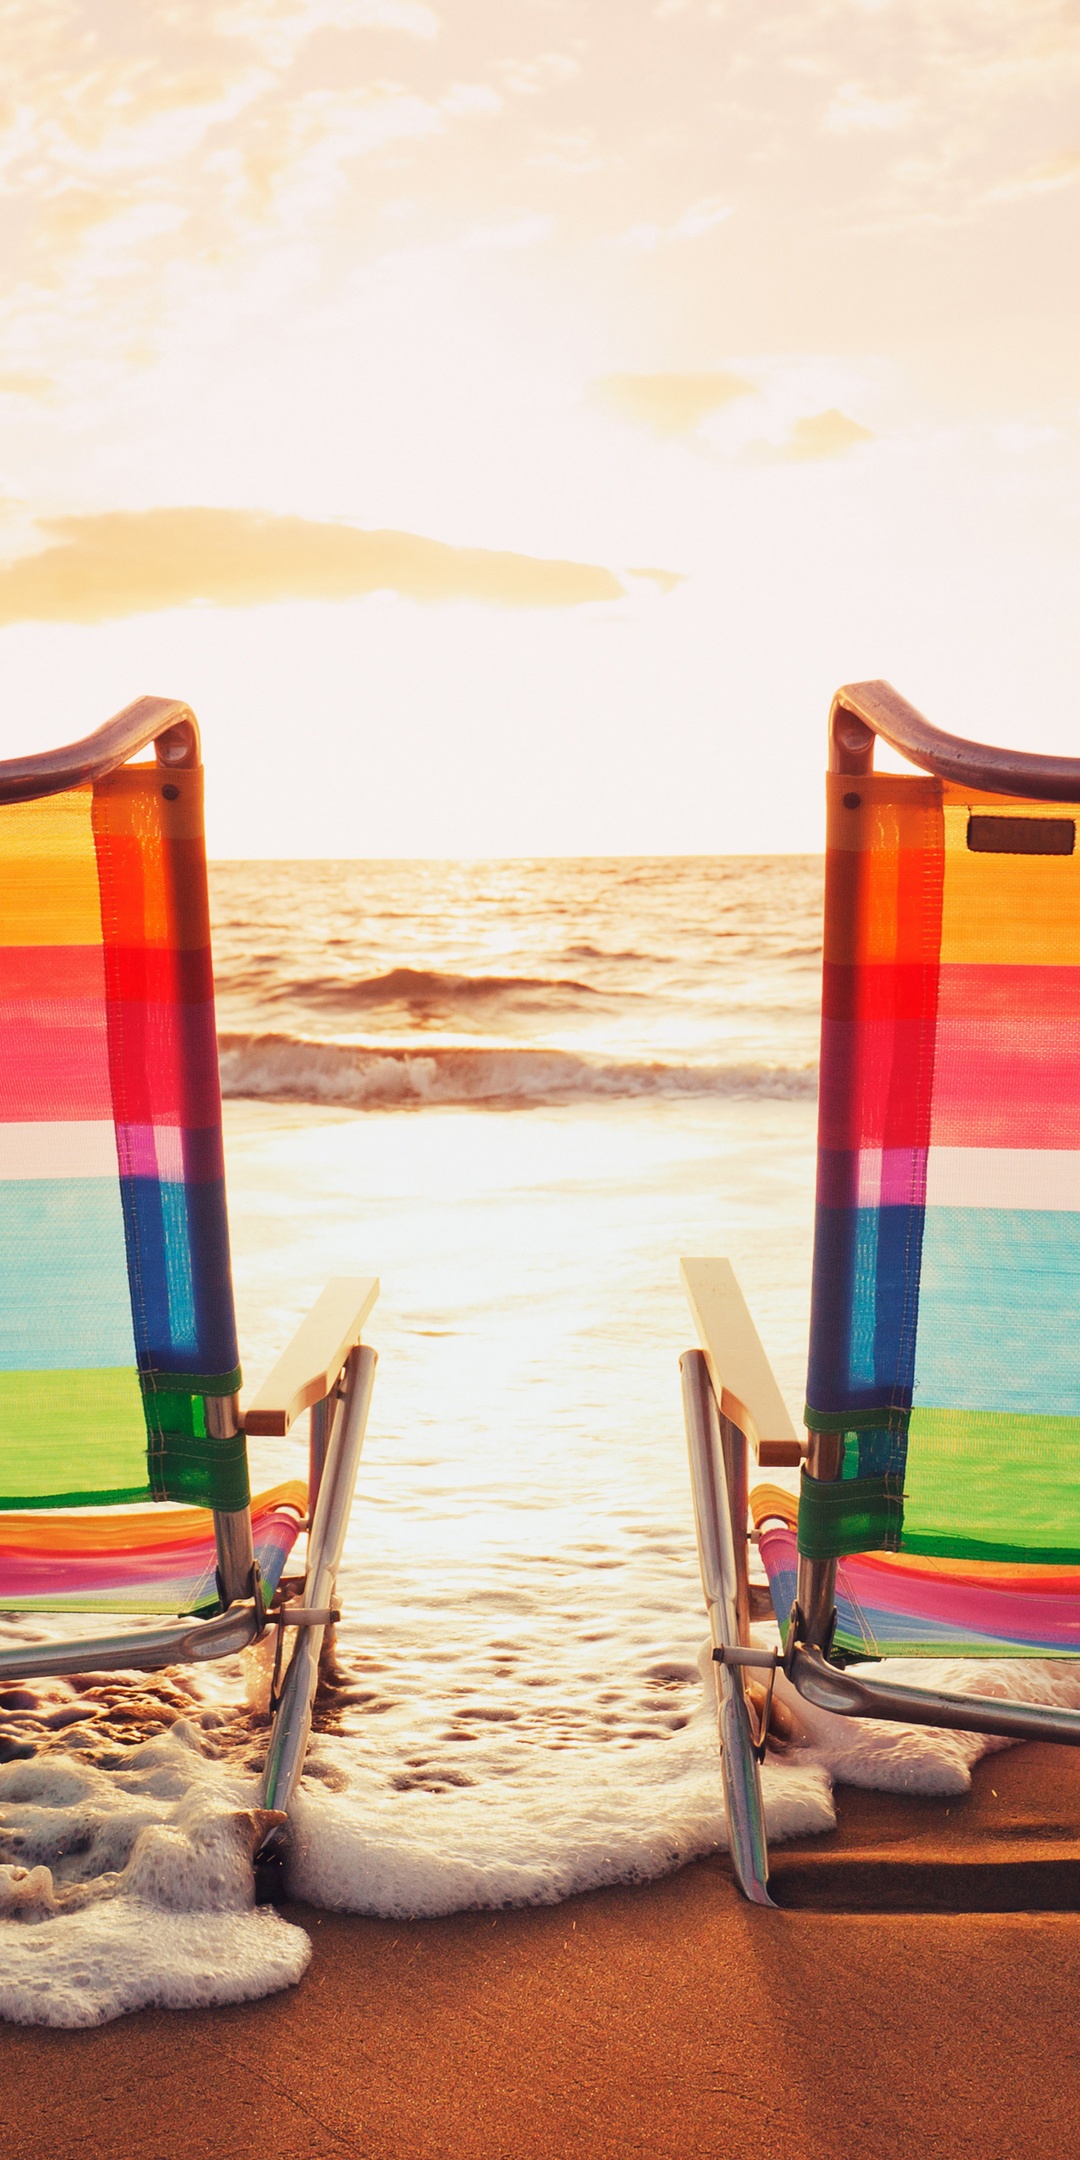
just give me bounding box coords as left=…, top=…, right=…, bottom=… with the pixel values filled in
left=0, top=858, right=1076, bottom=2024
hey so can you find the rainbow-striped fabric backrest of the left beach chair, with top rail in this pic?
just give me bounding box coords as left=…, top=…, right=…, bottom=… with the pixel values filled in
left=0, top=700, right=248, bottom=1510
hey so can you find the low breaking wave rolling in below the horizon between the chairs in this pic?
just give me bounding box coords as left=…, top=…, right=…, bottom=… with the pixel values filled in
left=218, top=1035, right=816, bottom=1110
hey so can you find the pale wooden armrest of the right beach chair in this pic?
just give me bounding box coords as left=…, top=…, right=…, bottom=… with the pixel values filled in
left=678, top=1259, right=806, bottom=1467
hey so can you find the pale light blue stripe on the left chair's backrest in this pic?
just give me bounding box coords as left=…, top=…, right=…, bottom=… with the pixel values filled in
left=0, top=1177, right=136, bottom=1372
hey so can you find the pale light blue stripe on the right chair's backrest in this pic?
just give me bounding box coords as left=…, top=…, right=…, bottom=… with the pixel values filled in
left=914, top=1207, right=1080, bottom=1417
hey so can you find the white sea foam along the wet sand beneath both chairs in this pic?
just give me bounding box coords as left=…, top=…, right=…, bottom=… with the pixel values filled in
left=0, top=1659, right=1080, bottom=2026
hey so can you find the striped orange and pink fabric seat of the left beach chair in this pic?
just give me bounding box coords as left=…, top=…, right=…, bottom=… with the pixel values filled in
left=0, top=1480, right=307, bottom=1616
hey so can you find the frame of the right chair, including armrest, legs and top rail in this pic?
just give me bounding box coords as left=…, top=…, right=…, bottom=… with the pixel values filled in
left=680, top=683, right=1080, bottom=1905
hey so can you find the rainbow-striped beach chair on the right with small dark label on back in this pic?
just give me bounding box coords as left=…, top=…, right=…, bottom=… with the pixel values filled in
left=683, top=683, right=1080, bottom=1905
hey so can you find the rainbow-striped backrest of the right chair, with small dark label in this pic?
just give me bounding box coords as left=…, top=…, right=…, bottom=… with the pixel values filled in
left=799, top=685, right=1080, bottom=1566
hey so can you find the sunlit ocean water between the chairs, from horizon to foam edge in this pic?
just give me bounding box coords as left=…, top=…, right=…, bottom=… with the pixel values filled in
left=214, top=860, right=821, bottom=1857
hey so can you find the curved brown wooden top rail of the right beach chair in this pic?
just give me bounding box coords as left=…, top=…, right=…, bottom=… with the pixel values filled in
left=829, top=683, right=1080, bottom=804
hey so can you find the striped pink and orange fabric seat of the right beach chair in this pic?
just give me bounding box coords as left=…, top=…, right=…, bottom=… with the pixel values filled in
left=750, top=1486, right=1080, bottom=1659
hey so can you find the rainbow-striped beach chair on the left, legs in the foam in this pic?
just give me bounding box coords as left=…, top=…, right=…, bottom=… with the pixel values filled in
left=0, top=698, right=378, bottom=1864
